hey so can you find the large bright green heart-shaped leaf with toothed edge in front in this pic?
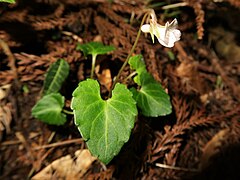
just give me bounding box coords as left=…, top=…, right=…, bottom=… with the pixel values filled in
left=71, top=79, right=137, bottom=164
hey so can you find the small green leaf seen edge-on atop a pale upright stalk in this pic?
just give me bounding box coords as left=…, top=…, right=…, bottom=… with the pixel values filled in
left=77, top=42, right=115, bottom=56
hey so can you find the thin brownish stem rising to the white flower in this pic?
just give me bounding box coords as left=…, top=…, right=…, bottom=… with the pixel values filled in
left=108, top=12, right=149, bottom=97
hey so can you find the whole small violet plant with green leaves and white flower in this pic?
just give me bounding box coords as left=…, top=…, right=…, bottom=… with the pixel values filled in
left=32, top=10, right=181, bottom=164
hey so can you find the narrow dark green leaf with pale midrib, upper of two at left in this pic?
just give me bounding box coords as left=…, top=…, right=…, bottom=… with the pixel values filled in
left=43, top=59, right=69, bottom=95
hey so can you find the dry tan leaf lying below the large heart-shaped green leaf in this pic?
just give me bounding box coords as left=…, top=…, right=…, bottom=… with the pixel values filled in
left=32, top=149, right=96, bottom=180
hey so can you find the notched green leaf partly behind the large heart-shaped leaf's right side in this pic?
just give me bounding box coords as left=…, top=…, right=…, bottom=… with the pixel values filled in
left=129, top=55, right=172, bottom=117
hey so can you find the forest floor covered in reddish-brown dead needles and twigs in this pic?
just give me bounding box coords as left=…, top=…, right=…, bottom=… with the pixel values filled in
left=0, top=0, right=240, bottom=180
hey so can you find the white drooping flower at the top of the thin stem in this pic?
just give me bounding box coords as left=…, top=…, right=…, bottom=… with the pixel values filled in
left=141, top=12, right=181, bottom=47
